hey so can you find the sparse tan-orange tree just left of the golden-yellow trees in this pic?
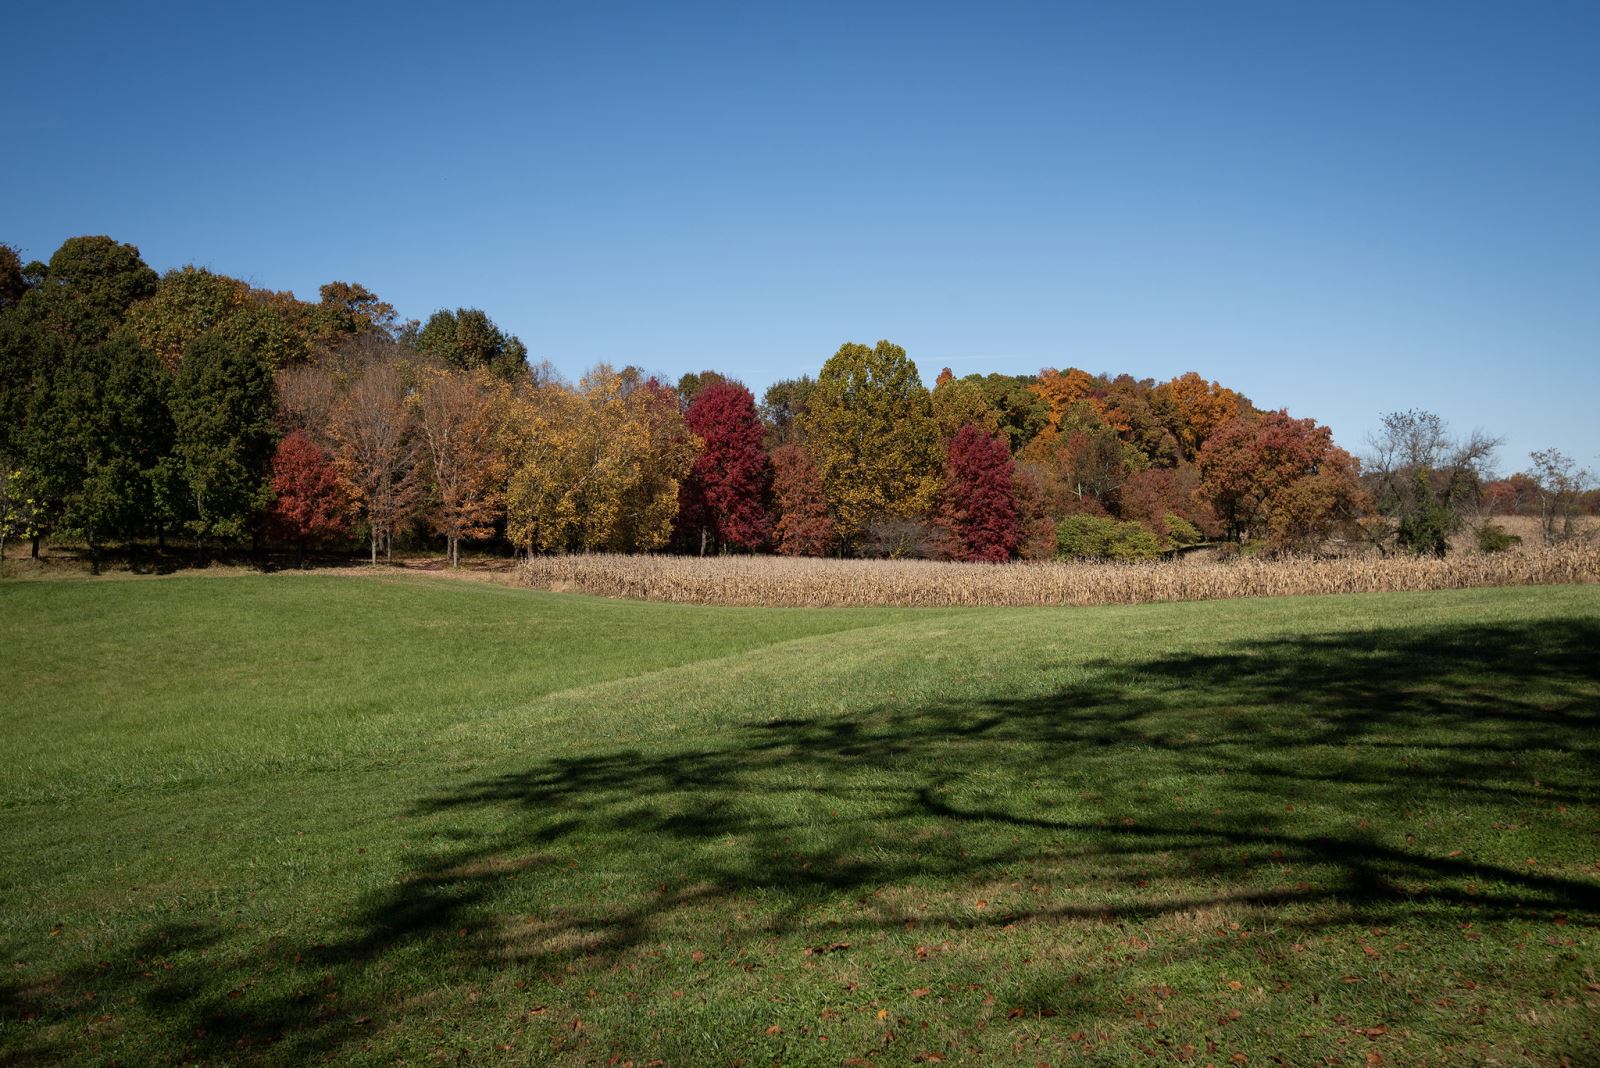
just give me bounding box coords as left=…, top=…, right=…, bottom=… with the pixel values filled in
left=411, top=366, right=507, bottom=568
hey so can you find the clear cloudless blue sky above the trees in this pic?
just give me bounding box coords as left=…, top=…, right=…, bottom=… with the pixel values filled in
left=0, top=0, right=1600, bottom=470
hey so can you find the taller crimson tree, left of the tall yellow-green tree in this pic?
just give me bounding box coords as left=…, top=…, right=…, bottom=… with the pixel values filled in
left=678, top=381, right=771, bottom=548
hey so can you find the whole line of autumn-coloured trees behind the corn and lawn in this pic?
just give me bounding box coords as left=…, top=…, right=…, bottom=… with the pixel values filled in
left=0, top=237, right=1597, bottom=566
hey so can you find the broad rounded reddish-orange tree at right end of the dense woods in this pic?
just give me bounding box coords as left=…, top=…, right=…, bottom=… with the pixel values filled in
left=1198, top=411, right=1365, bottom=550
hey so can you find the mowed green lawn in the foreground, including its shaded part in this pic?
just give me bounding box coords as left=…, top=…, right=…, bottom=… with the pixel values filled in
left=0, top=576, right=1600, bottom=1068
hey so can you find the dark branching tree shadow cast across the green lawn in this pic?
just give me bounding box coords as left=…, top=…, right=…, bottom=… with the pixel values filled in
left=0, top=620, right=1600, bottom=1063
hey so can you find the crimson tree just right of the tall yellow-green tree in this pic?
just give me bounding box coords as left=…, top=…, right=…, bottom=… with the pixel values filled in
left=939, top=425, right=1021, bottom=561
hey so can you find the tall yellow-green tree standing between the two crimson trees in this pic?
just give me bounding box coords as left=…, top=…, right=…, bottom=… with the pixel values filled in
left=802, top=341, right=942, bottom=539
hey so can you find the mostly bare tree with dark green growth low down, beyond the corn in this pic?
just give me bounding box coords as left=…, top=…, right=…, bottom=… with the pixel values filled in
left=1362, top=409, right=1499, bottom=556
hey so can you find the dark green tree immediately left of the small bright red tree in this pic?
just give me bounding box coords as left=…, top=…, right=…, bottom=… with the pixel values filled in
left=171, top=337, right=277, bottom=561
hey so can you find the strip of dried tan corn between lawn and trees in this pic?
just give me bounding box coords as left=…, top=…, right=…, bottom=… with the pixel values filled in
left=518, top=545, right=1600, bottom=608
